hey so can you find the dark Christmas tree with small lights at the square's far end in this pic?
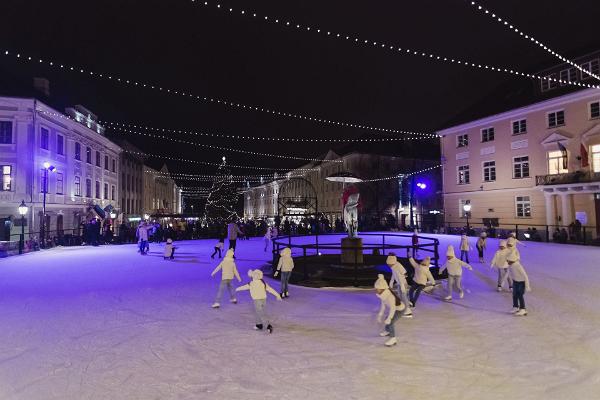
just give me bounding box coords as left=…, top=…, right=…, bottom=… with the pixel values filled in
left=204, top=157, right=238, bottom=224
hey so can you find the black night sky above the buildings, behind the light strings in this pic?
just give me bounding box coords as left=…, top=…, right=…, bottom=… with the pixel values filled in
left=0, top=0, right=600, bottom=194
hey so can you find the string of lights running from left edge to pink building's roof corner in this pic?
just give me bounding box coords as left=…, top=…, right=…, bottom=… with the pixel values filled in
left=4, top=50, right=437, bottom=137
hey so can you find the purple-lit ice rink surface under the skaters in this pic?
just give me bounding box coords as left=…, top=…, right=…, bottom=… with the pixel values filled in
left=0, top=235, right=600, bottom=400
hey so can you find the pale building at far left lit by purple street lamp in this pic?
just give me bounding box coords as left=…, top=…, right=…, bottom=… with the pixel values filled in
left=0, top=97, right=121, bottom=240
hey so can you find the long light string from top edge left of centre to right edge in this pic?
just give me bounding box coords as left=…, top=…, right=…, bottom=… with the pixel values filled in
left=191, top=0, right=600, bottom=90
